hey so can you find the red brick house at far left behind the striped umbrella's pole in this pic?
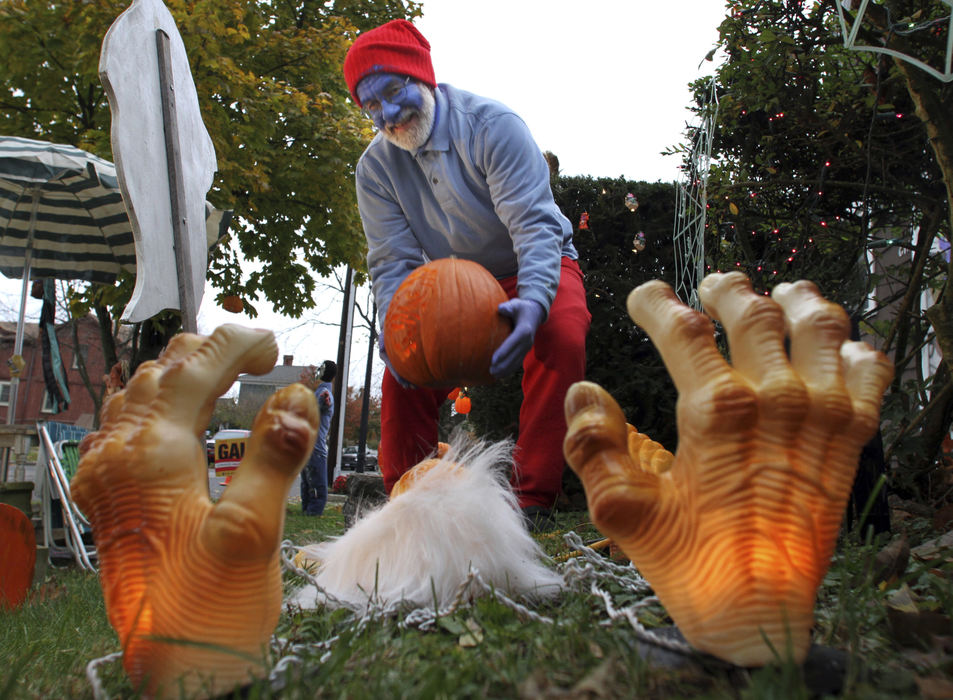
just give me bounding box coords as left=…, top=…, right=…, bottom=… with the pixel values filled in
left=0, top=315, right=115, bottom=428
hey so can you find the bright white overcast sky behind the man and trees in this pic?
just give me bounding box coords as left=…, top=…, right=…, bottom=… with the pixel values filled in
left=0, top=0, right=724, bottom=385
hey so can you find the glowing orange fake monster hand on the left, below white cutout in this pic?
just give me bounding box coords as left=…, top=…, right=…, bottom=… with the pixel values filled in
left=72, top=325, right=318, bottom=697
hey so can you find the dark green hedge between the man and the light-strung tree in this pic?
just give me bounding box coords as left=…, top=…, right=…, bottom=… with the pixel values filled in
left=454, top=177, right=677, bottom=450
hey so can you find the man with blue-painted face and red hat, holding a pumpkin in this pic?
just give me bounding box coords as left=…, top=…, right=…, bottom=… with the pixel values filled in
left=344, top=20, right=591, bottom=529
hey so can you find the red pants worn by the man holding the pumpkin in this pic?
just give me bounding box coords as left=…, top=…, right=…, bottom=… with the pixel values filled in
left=378, top=258, right=592, bottom=508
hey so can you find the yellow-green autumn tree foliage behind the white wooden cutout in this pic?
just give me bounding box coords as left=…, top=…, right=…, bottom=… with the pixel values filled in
left=0, top=0, right=419, bottom=366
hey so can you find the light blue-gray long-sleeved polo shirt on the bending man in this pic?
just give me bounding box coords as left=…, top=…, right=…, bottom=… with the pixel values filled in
left=356, top=83, right=578, bottom=326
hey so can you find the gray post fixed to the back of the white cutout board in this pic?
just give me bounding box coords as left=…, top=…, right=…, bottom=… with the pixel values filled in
left=156, top=29, right=198, bottom=333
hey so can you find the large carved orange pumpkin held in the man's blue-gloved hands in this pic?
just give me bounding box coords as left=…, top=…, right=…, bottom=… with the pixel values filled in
left=384, top=258, right=512, bottom=387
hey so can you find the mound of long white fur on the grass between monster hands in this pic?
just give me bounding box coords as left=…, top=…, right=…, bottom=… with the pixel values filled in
left=289, top=442, right=563, bottom=609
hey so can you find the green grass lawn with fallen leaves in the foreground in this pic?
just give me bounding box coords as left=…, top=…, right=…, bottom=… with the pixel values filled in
left=0, top=505, right=953, bottom=700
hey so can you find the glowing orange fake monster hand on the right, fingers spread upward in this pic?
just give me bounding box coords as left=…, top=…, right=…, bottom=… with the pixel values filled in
left=565, top=273, right=893, bottom=666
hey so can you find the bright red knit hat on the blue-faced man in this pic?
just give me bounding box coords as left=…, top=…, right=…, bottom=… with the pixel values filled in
left=344, top=19, right=437, bottom=106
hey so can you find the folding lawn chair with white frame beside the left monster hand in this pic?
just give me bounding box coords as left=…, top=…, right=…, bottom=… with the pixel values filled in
left=36, top=423, right=96, bottom=571
